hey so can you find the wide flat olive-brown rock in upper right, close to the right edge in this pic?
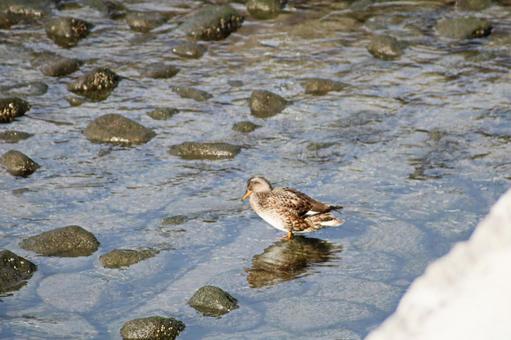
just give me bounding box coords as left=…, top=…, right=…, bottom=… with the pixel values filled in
left=436, top=17, right=493, bottom=40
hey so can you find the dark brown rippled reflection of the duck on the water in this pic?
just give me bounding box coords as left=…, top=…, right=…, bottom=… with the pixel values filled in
left=246, top=236, right=342, bottom=288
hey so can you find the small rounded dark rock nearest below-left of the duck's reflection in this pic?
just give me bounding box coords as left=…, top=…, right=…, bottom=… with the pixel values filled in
left=188, top=286, right=238, bottom=317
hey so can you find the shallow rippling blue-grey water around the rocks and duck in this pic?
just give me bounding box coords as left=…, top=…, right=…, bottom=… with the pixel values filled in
left=0, top=1, right=511, bottom=339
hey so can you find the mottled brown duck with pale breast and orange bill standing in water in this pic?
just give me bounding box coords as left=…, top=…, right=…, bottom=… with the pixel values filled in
left=242, top=176, right=344, bottom=240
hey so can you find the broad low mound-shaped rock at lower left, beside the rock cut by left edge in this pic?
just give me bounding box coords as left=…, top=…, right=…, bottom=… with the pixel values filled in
left=20, top=225, right=99, bottom=257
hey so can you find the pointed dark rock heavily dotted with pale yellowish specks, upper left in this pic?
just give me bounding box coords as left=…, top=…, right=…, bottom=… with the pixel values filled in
left=67, top=68, right=121, bottom=100
